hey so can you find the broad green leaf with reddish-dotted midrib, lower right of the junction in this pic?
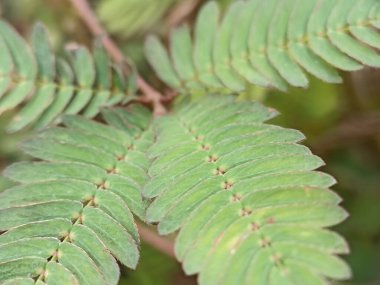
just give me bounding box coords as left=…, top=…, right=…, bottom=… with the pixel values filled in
left=143, top=96, right=350, bottom=285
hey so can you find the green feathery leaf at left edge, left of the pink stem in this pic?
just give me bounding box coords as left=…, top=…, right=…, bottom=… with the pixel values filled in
left=0, top=22, right=134, bottom=131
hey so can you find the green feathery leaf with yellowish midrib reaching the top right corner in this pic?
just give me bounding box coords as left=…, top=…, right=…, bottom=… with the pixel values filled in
left=146, top=0, right=380, bottom=93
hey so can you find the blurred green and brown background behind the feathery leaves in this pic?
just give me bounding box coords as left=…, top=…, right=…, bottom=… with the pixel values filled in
left=0, top=0, right=380, bottom=285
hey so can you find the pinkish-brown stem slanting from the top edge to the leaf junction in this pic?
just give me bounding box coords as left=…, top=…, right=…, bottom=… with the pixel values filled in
left=69, top=0, right=166, bottom=116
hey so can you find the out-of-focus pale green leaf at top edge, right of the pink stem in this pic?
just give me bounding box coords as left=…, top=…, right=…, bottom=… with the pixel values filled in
left=97, top=0, right=178, bottom=37
